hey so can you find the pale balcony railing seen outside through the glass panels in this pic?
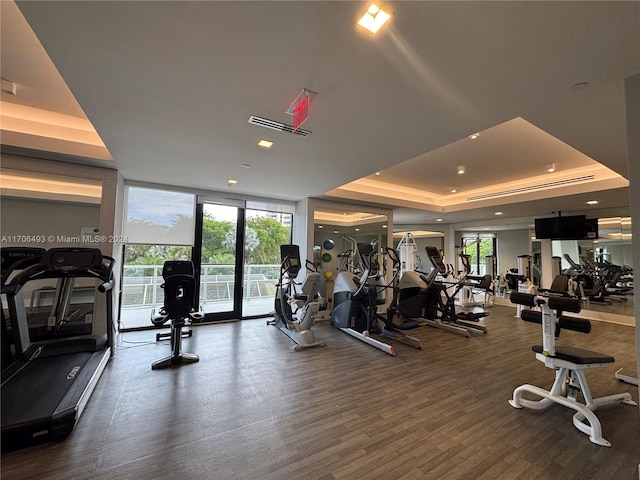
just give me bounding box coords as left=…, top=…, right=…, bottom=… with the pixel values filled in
left=121, top=265, right=280, bottom=308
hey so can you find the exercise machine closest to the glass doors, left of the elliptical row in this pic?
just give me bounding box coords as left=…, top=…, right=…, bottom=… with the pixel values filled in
left=267, top=245, right=326, bottom=351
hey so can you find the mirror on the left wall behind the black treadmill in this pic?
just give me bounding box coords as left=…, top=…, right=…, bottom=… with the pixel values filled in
left=0, top=168, right=102, bottom=339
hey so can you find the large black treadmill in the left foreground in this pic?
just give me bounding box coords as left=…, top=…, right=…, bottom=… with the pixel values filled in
left=1, top=248, right=115, bottom=452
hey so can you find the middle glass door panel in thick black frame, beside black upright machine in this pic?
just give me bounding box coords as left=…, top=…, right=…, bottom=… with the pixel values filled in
left=193, top=202, right=244, bottom=322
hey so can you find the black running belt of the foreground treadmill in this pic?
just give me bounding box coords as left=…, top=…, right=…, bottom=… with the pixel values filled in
left=2, top=352, right=92, bottom=429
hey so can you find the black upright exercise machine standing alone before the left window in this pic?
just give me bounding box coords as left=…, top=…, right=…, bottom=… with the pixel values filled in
left=151, top=260, right=204, bottom=370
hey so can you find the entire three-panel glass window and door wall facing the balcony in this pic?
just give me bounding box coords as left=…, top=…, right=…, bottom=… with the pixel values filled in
left=120, top=186, right=293, bottom=330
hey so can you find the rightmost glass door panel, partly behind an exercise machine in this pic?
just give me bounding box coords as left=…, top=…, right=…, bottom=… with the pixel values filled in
left=242, top=209, right=293, bottom=317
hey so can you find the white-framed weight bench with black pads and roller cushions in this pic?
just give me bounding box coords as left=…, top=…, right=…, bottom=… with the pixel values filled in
left=509, top=292, right=637, bottom=447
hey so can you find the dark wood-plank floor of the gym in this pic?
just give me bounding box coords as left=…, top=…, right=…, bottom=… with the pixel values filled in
left=1, top=306, right=640, bottom=480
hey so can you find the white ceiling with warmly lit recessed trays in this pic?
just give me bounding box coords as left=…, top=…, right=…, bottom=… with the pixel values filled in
left=1, top=1, right=640, bottom=229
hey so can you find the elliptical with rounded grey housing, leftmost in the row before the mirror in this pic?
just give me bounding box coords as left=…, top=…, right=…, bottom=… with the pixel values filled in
left=331, top=243, right=424, bottom=357
